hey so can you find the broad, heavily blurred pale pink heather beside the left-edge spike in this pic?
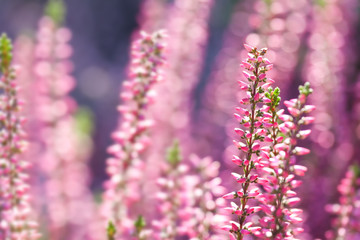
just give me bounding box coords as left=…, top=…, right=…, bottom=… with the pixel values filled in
left=14, top=17, right=103, bottom=240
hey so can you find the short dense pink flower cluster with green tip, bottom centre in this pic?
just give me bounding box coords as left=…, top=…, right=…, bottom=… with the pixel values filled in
left=153, top=142, right=225, bottom=240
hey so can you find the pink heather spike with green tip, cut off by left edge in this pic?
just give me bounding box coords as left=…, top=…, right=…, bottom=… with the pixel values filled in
left=0, top=34, right=40, bottom=240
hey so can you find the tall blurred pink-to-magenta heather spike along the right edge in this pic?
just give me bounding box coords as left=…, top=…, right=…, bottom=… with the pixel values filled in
left=303, top=0, right=360, bottom=233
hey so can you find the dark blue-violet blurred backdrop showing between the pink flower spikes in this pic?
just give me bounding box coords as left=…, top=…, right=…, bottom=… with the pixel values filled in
left=0, top=0, right=241, bottom=189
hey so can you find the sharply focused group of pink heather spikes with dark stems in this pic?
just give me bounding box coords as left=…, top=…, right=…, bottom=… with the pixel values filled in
left=223, top=45, right=314, bottom=239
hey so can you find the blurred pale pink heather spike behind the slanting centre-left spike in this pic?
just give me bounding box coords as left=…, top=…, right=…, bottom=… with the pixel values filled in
left=146, top=0, right=213, bottom=161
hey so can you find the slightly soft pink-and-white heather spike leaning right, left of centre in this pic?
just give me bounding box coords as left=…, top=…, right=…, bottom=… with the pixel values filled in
left=103, top=31, right=164, bottom=237
